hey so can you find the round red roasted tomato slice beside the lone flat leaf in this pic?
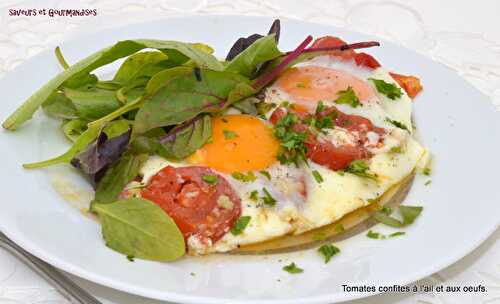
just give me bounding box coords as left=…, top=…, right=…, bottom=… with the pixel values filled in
left=141, top=166, right=241, bottom=244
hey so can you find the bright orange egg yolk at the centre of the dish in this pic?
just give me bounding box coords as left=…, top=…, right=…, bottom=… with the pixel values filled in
left=188, top=115, right=279, bottom=173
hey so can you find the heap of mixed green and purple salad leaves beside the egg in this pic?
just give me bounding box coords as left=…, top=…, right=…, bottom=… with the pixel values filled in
left=2, top=20, right=378, bottom=261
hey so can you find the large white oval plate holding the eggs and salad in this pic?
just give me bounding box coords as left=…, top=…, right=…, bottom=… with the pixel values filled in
left=0, top=16, right=500, bottom=304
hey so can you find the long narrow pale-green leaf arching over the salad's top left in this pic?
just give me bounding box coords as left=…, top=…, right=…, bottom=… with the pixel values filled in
left=2, top=39, right=223, bottom=130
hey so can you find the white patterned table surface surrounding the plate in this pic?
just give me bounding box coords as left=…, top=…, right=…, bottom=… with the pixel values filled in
left=0, top=0, right=500, bottom=304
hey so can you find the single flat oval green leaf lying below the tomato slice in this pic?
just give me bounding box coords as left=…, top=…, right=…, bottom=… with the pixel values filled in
left=94, top=198, right=186, bottom=262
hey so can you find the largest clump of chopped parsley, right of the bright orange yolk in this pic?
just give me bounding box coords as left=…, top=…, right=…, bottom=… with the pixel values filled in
left=273, top=113, right=307, bottom=166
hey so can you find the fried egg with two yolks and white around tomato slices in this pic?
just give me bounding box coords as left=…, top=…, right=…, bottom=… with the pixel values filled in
left=135, top=55, right=426, bottom=254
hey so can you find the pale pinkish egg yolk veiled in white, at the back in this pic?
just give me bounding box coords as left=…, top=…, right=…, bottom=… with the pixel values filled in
left=276, top=66, right=375, bottom=106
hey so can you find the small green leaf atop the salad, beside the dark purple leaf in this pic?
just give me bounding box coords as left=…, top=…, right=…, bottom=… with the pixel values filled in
left=224, top=34, right=283, bottom=77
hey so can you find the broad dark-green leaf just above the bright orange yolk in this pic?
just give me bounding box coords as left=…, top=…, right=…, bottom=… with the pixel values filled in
left=134, top=68, right=248, bottom=134
